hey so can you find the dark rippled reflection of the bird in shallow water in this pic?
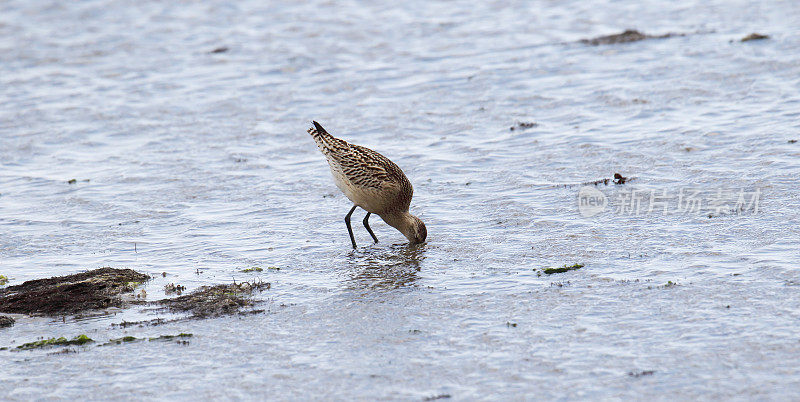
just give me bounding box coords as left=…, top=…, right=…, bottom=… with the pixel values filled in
left=347, top=244, right=425, bottom=289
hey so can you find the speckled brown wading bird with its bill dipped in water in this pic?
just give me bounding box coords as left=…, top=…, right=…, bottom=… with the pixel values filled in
left=308, top=121, right=428, bottom=248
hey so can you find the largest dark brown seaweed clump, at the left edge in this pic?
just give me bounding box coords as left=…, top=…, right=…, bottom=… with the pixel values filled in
left=0, top=267, right=150, bottom=315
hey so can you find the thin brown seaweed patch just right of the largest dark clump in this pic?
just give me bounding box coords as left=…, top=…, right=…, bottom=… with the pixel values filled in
left=157, top=281, right=270, bottom=318
